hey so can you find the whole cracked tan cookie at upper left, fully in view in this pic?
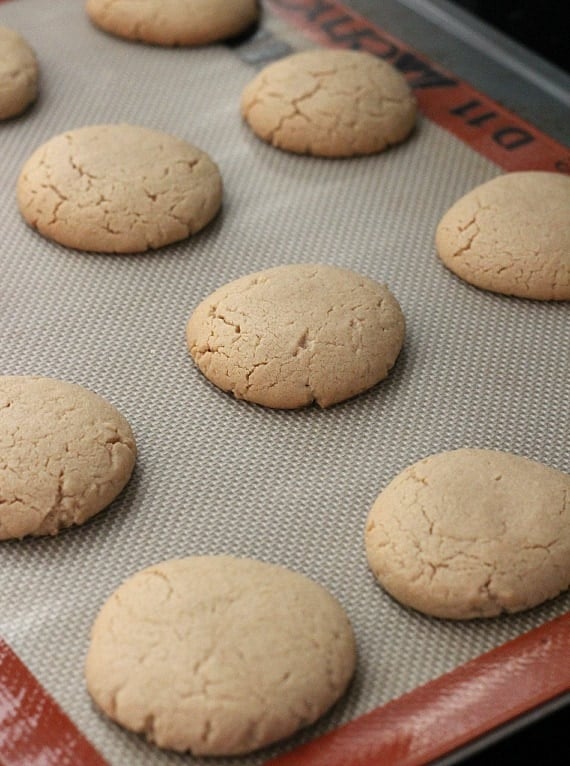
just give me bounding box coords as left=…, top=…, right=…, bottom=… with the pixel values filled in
left=18, top=125, right=222, bottom=253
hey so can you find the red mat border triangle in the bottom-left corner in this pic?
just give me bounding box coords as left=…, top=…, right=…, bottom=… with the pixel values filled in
left=0, top=638, right=107, bottom=766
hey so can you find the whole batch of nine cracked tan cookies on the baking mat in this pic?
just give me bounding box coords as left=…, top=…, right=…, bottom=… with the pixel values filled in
left=0, top=0, right=570, bottom=755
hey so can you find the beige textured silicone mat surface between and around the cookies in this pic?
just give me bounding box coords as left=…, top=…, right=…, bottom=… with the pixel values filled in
left=0, top=0, right=570, bottom=766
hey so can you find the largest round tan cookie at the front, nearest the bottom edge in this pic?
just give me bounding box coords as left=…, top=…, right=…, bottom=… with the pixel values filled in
left=85, top=556, right=356, bottom=755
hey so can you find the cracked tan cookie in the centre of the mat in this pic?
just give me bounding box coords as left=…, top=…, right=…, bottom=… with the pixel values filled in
left=186, top=264, right=404, bottom=409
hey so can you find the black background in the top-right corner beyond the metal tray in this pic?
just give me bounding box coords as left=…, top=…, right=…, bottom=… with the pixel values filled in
left=451, top=0, right=570, bottom=73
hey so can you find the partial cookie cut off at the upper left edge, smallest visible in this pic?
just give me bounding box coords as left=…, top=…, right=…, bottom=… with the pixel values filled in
left=0, top=26, right=38, bottom=120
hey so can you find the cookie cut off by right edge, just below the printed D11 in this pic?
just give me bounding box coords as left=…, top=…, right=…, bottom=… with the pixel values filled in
left=436, top=171, right=570, bottom=301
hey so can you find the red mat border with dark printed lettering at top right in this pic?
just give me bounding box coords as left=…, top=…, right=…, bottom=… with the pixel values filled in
left=265, top=0, right=570, bottom=173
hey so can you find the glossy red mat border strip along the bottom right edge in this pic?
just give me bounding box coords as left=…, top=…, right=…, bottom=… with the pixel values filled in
left=266, top=614, right=570, bottom=766
